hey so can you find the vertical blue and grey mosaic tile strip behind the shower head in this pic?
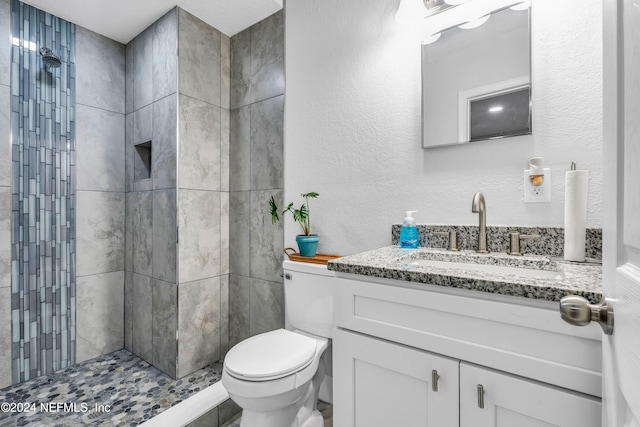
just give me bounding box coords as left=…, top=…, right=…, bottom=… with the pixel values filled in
left=11, top=0, right=75, bottom=383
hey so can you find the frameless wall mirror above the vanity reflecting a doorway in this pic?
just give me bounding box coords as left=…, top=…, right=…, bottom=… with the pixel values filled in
left=422, top=2, right=531, bottom=148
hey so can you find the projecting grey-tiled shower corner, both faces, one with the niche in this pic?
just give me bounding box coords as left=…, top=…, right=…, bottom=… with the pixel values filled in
left=124, top=8, right=230, bottom=377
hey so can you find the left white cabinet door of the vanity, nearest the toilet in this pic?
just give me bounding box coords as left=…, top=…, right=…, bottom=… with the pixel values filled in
left=333, top=330, right=459, bottom=427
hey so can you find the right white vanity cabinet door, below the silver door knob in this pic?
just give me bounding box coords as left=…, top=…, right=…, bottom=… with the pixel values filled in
left=460, top=362, right=601, bottom=427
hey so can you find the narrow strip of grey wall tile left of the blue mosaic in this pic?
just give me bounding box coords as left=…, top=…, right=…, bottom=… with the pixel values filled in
left=0, top=0, right=11, bottom=388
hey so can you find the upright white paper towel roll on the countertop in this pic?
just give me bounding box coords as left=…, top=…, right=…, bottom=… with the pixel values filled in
left=564, top=170, right=589, bottom=262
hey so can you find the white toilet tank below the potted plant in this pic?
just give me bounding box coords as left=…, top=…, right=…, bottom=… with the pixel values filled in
left=282, top=261, right=336, bottom=338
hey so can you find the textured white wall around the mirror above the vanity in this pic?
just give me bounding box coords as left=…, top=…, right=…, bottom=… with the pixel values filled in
left=284, top=0, right=602, bottom=254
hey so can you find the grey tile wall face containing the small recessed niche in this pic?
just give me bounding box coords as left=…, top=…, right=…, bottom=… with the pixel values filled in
left=123, top=8, right=178, bottom=377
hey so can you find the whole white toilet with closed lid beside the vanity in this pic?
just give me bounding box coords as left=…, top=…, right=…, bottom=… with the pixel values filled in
left=222, top=261, right=335, bottom=427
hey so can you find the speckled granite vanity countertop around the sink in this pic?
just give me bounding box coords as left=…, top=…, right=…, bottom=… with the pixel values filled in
left=328, top=245, right=602, bottom=304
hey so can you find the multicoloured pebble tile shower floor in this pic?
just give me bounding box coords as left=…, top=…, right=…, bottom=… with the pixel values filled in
left=0, top=350, right=222, bottom=427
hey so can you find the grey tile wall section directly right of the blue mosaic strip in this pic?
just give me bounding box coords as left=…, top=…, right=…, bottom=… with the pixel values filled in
left=76, top=27, right=125, bottom=362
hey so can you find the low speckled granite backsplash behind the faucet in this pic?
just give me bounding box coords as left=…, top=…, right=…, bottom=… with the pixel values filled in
left=391, top=224, right=602, bottom=260
